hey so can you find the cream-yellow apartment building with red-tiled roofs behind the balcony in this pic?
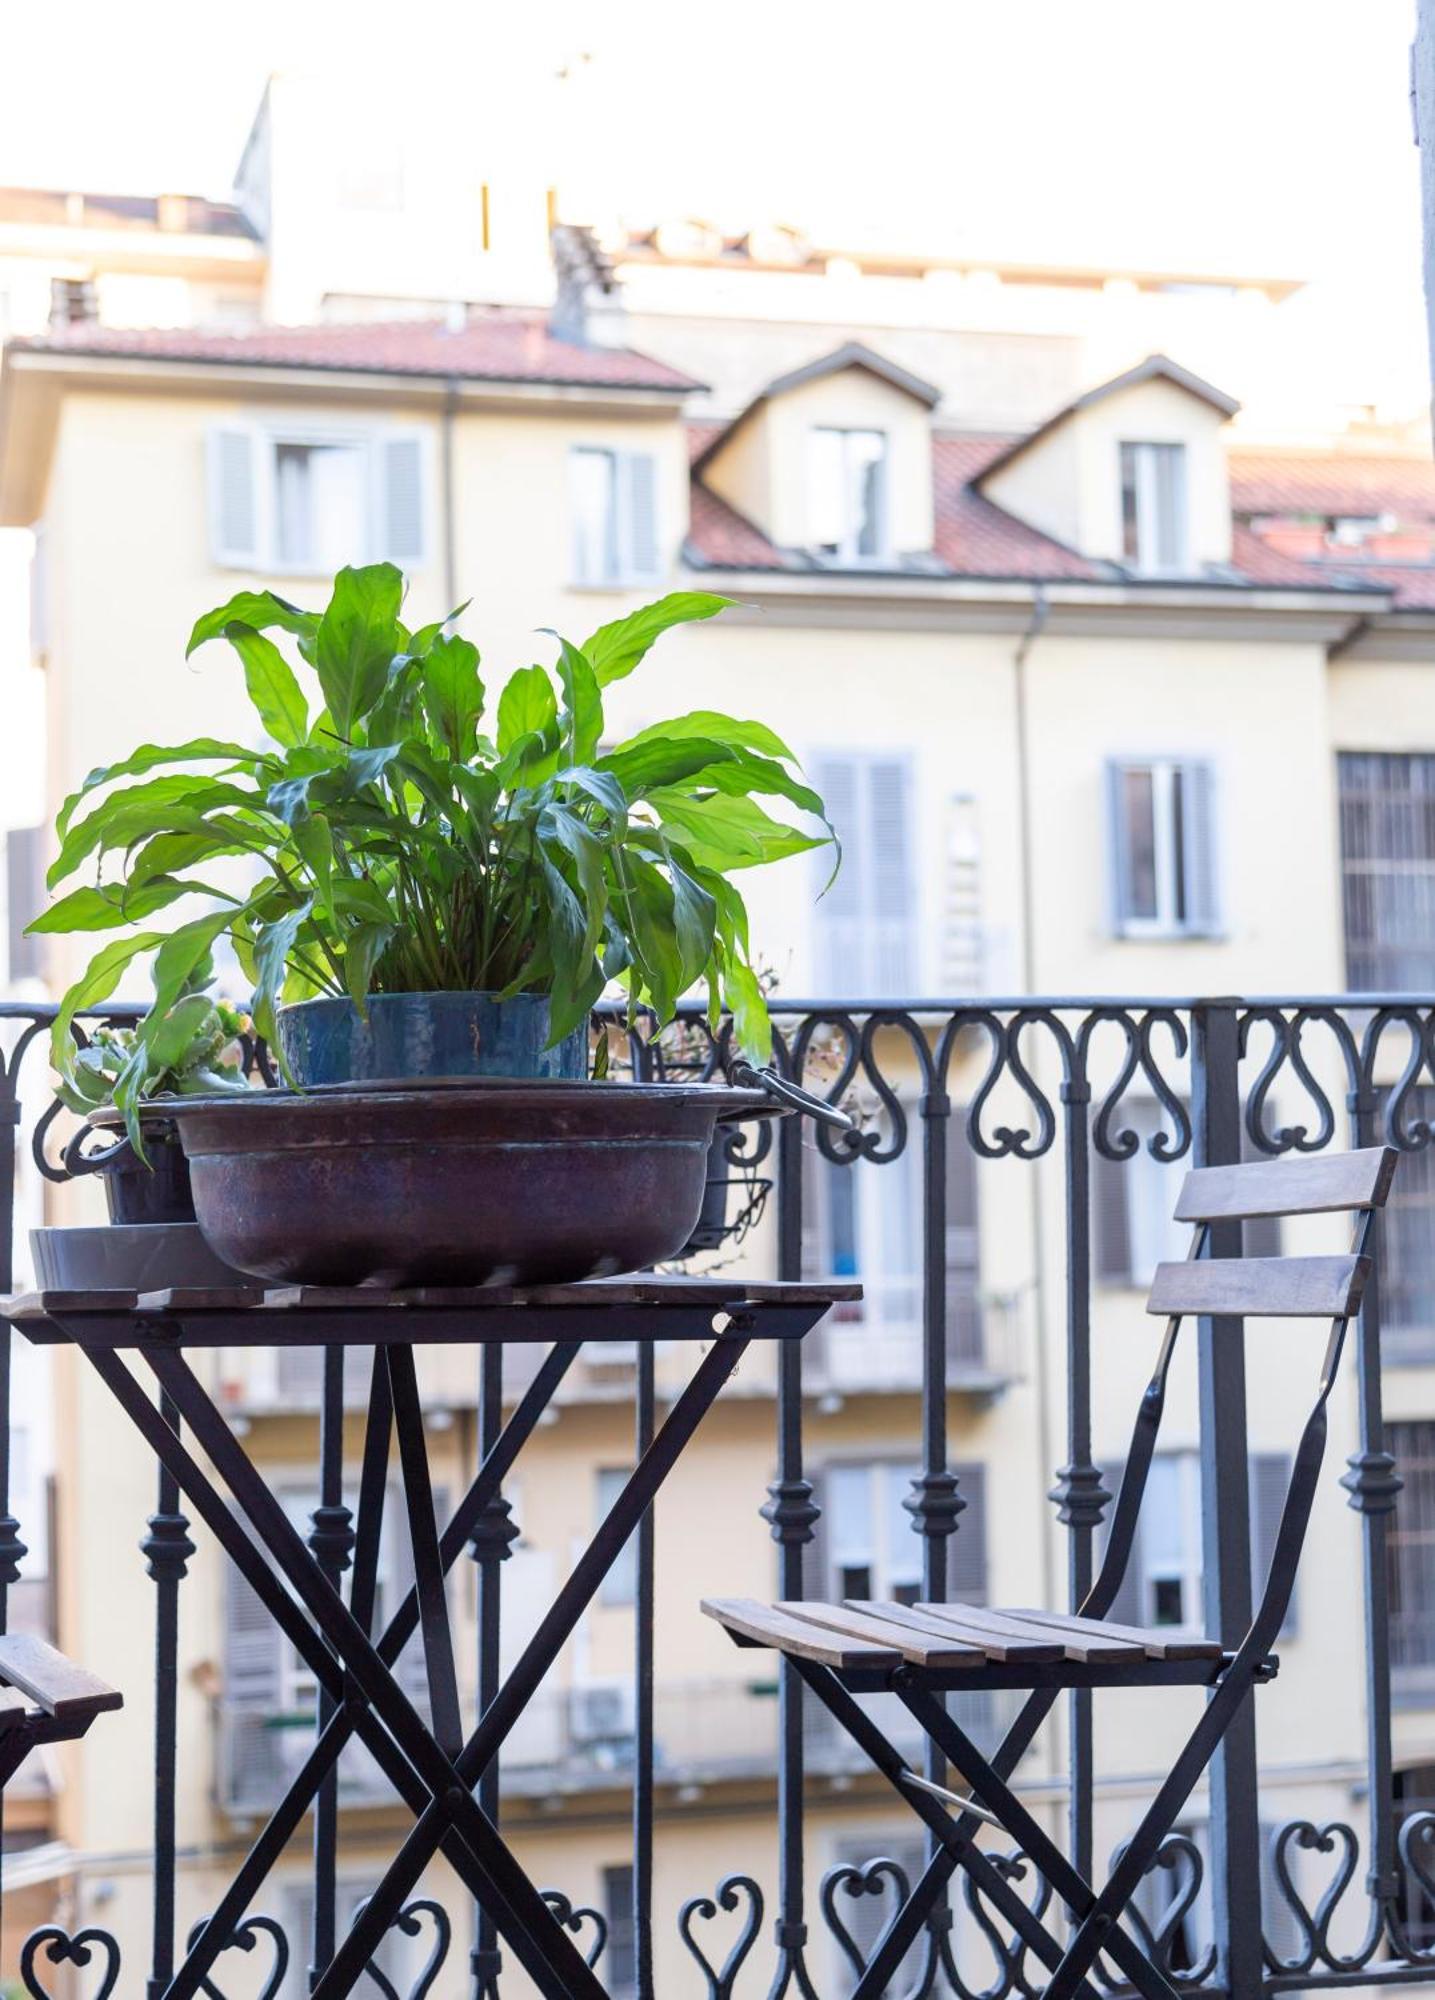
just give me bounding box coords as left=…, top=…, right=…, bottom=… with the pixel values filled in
left=0, top=97, right=1435, bottom=1994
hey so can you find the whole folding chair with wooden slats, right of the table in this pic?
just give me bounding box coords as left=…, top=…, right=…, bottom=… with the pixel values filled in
left=704, top=1148, right=1397, bottom=2000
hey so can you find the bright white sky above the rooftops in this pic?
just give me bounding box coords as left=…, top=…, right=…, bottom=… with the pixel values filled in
left=0, top=0, right=1419, bottom=384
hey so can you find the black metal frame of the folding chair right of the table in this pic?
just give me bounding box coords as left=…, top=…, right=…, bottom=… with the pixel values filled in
left=714, top=1148, right=1397, bottom=2000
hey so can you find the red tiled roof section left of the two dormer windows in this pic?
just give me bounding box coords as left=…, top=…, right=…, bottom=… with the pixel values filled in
left=12, top=312, right=702, bottom=392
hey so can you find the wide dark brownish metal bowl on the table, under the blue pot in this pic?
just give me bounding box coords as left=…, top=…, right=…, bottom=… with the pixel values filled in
left=166, top=1078, right=773, bottom=1284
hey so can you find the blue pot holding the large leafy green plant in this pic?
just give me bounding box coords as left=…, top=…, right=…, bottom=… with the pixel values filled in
left=278, top=994, right=588, bottom=1086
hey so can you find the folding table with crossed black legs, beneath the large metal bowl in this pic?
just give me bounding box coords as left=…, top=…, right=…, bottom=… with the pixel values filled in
left=6, top=1280, right=843, bottom=2000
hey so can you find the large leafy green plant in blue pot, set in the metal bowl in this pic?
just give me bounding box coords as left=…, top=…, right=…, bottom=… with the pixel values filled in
left=30, top=564, right=831, bottom=1096
